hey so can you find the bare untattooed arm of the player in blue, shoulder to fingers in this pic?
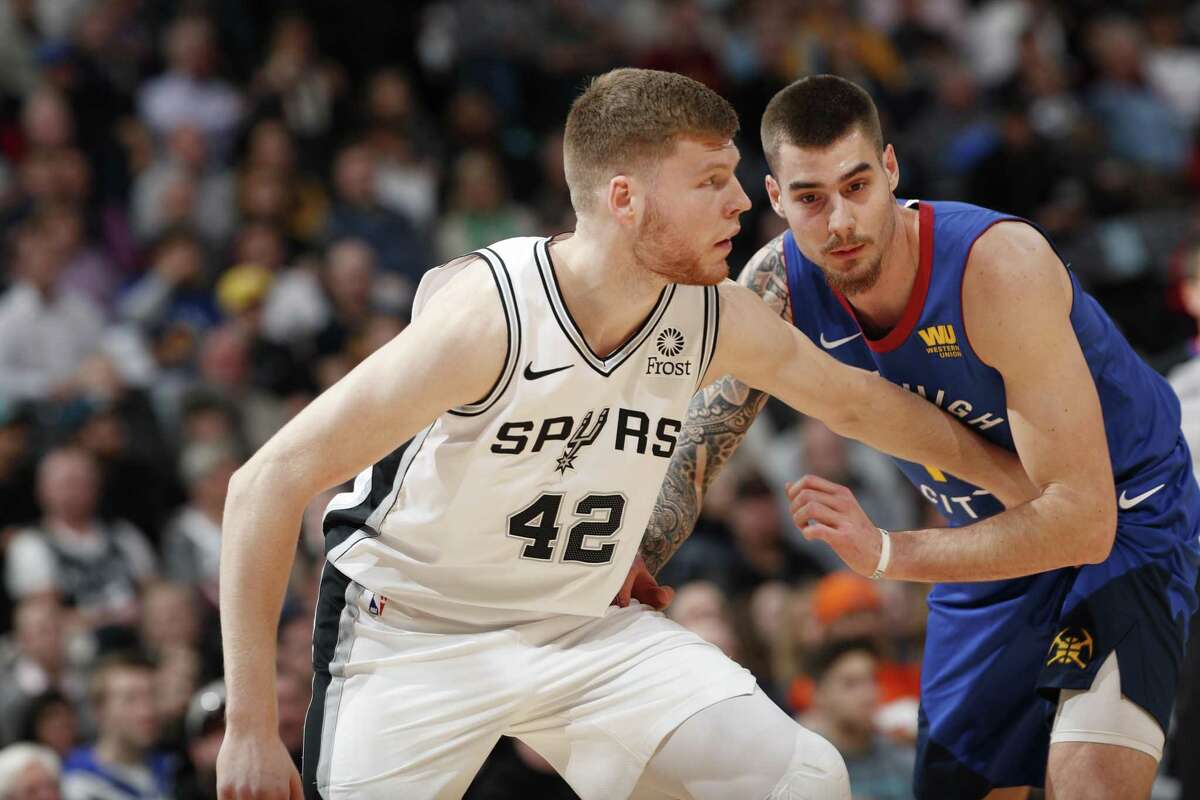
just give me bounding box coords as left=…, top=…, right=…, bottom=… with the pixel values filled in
left=792, top=222, right=1116, bottom=582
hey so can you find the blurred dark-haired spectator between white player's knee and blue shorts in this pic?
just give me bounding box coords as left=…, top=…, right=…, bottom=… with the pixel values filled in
left=800, top=639, right=914, bottom=800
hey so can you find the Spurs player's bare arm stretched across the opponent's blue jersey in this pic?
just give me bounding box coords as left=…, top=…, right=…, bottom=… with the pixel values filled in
left=713, top=283, right=1034, bottom=506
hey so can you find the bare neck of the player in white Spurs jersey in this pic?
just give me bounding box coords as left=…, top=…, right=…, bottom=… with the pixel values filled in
left=550, top=222, right=667, bottom=355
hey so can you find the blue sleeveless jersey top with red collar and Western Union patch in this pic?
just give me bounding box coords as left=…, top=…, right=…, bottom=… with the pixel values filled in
left=784, top=201, right=1200, bottom=610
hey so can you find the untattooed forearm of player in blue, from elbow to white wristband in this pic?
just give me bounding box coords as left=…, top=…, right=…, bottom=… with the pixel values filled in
left=887, top=488, right=1115, bottom=583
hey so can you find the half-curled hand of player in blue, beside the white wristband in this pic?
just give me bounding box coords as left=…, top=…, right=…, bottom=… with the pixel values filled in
left=787, top=475, right=883, bottom=577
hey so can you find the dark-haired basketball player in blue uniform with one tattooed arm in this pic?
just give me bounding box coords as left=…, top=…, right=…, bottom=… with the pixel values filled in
left=643, top=76, right=1200, bottom=800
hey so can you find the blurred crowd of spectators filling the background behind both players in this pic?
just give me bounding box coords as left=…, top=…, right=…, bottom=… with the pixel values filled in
left=0, top=0, right=1200, bottom=800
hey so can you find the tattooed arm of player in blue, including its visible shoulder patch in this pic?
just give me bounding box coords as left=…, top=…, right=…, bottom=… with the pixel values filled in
left=641, top=236, right=792, bottom=575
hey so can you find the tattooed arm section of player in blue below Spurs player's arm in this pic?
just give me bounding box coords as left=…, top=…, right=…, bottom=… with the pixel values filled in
left=641, top=375, right=767, bottom=575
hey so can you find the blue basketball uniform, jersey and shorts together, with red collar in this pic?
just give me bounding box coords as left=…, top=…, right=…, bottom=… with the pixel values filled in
left=784, top=201, right=1200, bottom=800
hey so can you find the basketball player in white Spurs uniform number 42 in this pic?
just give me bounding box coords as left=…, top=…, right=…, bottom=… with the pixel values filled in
left=217, top=70, right=1030, bottom=800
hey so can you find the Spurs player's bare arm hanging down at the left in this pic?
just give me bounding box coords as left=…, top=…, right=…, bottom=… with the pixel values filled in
left=217, top=261, right=508, bottom=799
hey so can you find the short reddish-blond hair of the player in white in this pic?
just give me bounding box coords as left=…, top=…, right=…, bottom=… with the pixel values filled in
left=563, top=67, right=738, bottom=213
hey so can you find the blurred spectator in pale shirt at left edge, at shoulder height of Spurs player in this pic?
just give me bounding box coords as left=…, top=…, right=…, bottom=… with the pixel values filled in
left=0, top=221, right=103, bottom=401
